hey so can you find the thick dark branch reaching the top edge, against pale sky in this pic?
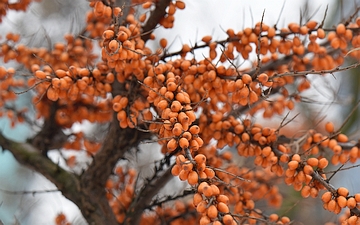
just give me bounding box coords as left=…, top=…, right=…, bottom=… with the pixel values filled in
left=141, top=0, right=171, bottom=42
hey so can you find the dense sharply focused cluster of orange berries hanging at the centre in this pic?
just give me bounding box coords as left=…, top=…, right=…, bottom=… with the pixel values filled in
left=143, top=64, right=203, bottom=152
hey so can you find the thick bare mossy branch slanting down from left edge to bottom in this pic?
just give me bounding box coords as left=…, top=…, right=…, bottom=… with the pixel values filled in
left=0, top=133, right=122, bottom=224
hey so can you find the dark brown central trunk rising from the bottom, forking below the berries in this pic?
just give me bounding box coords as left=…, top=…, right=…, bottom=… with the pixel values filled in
left=80, top=77, right=151, bottom=224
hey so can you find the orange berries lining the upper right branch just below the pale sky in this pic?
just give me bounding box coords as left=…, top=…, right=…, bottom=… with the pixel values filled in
left=202, top=19, right=360, bottom=71
